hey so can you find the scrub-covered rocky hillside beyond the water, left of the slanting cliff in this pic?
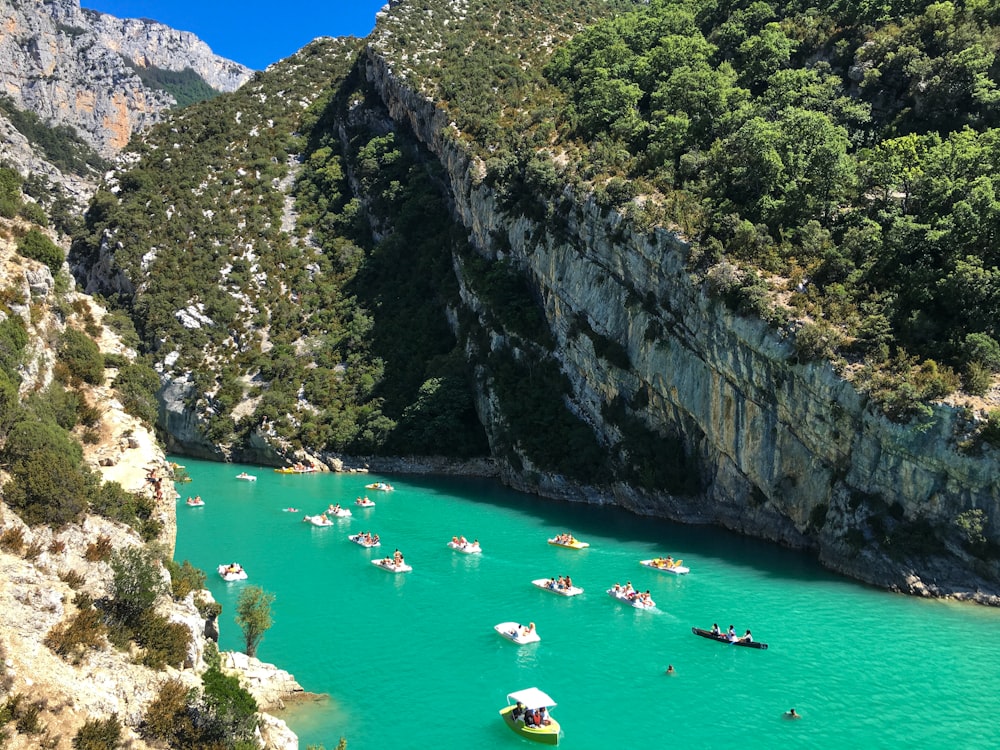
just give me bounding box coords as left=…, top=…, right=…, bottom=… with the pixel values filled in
left=71, top=40, right=485, bottom=462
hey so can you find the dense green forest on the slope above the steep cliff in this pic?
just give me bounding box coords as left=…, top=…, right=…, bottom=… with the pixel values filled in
left=374, top=0, right=1000, bottom=420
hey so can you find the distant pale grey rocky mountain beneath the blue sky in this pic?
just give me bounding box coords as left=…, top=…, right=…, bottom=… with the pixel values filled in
left=0, top=0, right=252, bottom=157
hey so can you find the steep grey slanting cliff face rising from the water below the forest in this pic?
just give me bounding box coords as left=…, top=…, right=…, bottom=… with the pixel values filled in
left=366, top=45, right=1000, bottom=603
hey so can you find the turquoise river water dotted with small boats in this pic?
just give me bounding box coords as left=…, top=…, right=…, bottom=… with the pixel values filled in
left=176, top=459, right=1000, bottom=750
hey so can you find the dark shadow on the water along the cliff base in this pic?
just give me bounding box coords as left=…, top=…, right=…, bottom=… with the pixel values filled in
left=405, top=475, right=848, bottom=586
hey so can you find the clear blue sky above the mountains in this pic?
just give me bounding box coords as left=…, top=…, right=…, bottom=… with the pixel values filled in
left=81, top=0, right=386, bottom=70
